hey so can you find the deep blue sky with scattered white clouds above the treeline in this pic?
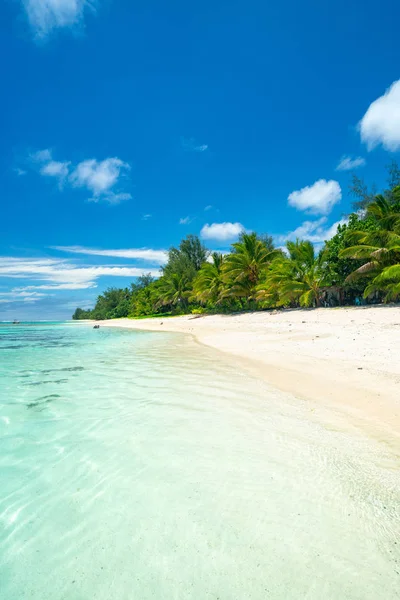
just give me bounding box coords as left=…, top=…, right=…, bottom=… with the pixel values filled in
left=0, top=0, right=400, bottom=319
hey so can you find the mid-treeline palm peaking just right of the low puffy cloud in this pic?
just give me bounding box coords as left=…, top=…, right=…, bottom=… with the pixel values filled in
left=223, top=232, right=279, bottom=300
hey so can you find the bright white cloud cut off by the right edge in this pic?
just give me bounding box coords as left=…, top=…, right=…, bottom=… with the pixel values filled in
left=359, top=79, right=400, bottom=152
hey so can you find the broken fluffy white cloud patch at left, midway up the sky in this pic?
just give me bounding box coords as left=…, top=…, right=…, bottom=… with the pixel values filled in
left=32, top=149, right=132, bottom=204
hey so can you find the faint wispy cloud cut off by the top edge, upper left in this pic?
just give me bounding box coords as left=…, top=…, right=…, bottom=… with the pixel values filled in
left=22, top=0, right=95, bottom=38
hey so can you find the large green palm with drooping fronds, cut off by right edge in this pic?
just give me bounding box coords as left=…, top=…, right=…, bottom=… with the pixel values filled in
left=340, top=193, right=400, bottom=299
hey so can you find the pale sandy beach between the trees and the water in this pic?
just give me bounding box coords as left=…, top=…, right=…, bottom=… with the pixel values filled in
left=97, top=306, right=400, bottom=452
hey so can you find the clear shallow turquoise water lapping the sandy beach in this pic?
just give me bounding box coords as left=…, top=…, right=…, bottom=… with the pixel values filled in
left=0, top=324, right=400, bottom=600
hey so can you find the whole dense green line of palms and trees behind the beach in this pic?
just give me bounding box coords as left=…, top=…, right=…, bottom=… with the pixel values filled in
left=73, top=183, right=400, bottom=319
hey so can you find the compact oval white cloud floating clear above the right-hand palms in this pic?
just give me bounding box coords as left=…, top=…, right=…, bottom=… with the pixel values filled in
left=288, top=179, right=342, bottom=215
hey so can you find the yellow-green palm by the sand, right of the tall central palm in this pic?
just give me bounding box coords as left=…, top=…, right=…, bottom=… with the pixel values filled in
left=257, top=240, right=325, bottom=307
